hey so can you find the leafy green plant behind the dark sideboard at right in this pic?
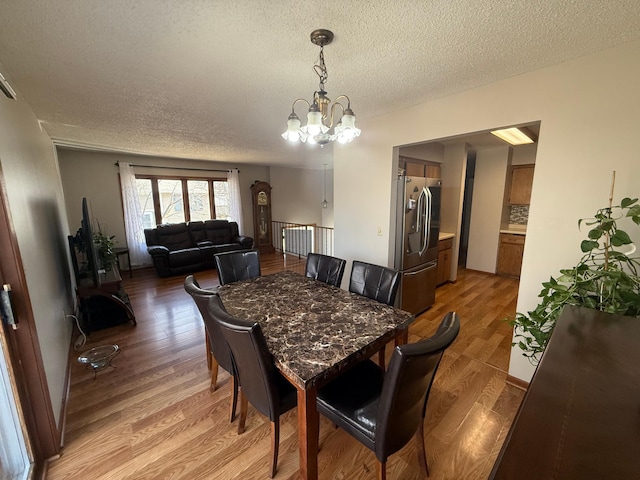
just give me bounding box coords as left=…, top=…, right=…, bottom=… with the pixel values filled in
left=507, top=182, right=640, bottom=365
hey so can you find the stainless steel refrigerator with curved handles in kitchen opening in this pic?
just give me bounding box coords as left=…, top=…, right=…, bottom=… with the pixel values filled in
left=395, top=176, right=442, bottom=314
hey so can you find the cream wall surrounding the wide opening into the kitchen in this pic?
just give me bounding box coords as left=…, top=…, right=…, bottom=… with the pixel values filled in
left=334, top=38, right=640, bottom=381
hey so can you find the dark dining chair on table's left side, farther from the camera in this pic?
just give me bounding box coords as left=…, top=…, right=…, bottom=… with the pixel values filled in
left=184, top=275, right=238, bottom=422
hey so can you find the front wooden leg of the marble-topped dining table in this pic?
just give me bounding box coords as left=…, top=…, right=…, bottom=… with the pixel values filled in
left=298, top=386, right=320, bottom=480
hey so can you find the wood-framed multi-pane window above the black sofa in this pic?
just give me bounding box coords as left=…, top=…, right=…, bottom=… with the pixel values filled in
left=136, top=175, right=229, bottom=228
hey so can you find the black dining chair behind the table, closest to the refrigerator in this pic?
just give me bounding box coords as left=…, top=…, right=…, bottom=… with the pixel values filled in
left=349, top=260, right=400, bottom=369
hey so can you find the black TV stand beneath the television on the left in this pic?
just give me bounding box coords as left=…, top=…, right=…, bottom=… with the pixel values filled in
left=78, top=265, right=137, bottom=332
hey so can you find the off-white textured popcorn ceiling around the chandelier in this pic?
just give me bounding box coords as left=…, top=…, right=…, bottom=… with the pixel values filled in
left=0, top=0, right=640, bottom=166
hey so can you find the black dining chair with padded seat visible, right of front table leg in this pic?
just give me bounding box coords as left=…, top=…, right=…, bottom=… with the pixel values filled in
left=318, top=312, right=460, bottom=480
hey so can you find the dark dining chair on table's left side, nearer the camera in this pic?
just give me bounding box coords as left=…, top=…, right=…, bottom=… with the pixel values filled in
left=209, top=295, right=297, bottom=478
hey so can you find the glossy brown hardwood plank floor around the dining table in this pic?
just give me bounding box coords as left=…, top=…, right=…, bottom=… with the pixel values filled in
left=47, top=254, right=524, bottom=480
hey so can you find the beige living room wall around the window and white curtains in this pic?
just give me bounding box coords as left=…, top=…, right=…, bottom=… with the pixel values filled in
left=58, top=148, right=270, bottom=246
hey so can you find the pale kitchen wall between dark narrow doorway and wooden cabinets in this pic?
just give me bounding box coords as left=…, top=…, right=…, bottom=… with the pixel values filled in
left=466, top=146, right=511, bottom=273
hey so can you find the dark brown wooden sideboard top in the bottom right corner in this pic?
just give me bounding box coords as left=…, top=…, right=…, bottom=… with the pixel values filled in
left=489, top=307, right=640, bottom=480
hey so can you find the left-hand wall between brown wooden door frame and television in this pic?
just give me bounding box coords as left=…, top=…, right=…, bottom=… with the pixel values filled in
left=0, top=80, right=74, bottom=428
